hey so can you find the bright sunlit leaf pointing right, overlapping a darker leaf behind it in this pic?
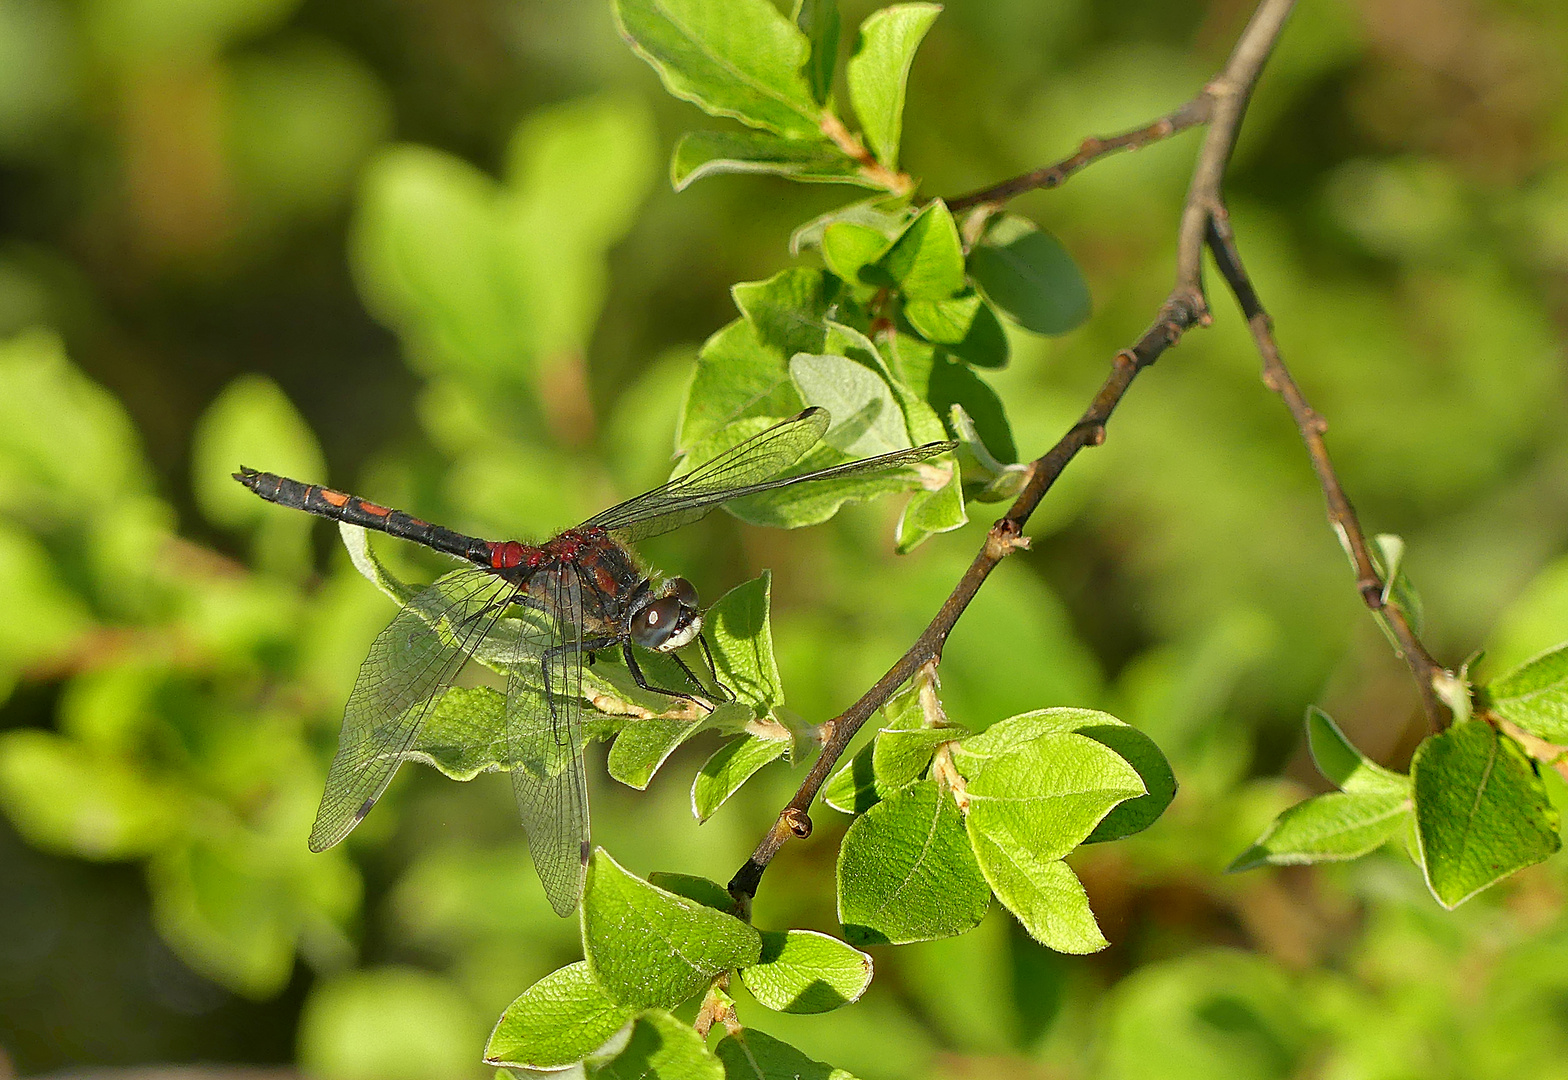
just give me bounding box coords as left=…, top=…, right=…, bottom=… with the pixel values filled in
left=955, top=732, right=1146, bottom=861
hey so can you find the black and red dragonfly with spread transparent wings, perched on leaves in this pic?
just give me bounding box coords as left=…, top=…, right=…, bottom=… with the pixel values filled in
left=234, top=408, right=958, bottom=915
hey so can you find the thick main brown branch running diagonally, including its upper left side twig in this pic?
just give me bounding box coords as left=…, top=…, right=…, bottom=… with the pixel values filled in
left=729, top=0, right=1294, bottom=911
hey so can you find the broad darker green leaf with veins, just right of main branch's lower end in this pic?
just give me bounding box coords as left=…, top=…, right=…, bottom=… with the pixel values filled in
left=839, top=781, right=991, bottom=945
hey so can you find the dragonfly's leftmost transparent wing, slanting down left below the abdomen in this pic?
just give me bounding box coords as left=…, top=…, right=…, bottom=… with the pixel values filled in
left=310, top=569, right=517, bottom=851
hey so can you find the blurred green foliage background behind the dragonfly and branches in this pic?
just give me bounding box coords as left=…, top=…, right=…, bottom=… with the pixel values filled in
left=0, top=0, right=1568, bottom=1080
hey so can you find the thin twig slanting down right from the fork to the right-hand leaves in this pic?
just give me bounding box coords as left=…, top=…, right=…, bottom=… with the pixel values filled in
left=1209, top=207, right=1447, bottom=732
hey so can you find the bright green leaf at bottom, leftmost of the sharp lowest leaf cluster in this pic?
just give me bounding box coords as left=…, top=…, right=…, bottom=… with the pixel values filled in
left=485, top=961, right=635, bottom=1069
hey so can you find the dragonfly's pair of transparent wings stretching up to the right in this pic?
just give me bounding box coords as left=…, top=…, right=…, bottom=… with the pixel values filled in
left=583, top=408, right=958, bottom=542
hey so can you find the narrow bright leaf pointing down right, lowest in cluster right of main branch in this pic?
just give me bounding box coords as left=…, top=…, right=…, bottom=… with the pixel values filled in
left=967, top=821, right=1110, bottom=953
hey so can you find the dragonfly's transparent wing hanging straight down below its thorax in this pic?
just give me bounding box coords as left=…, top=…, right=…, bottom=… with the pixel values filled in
left=506, top=566, right=588, bottom=915
